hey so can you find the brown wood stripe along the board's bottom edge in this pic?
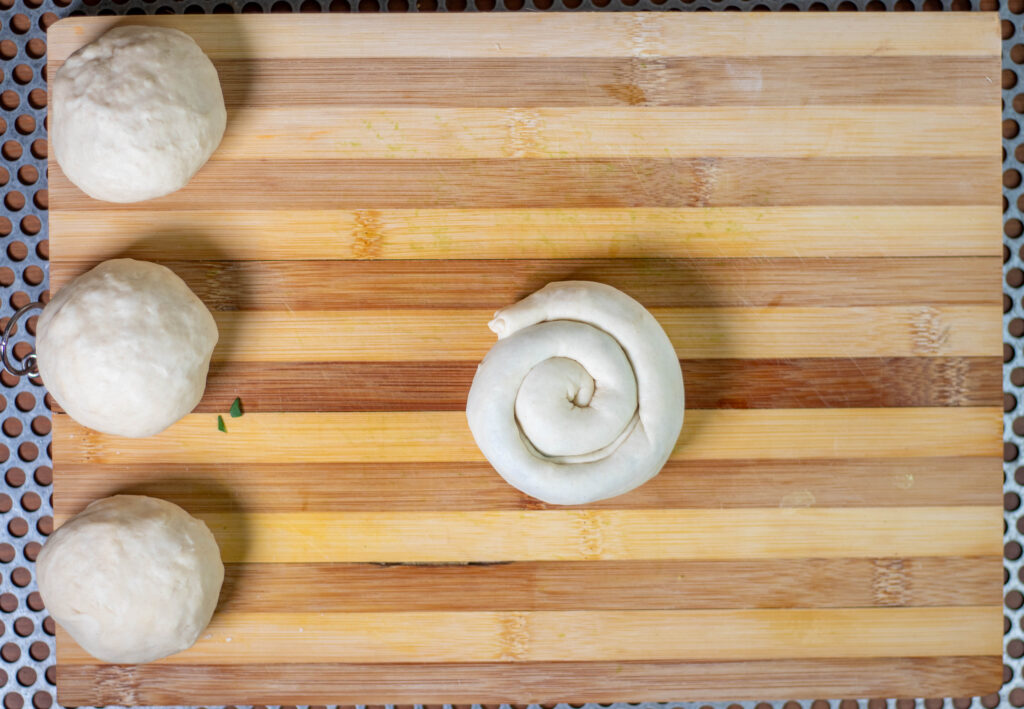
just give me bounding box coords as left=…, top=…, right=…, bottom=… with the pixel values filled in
left=57, top=655, right=1002, bottom=706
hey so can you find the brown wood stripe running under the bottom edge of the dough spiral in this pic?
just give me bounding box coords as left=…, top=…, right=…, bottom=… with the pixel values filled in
left=57, top=450, right=1001, bottom=515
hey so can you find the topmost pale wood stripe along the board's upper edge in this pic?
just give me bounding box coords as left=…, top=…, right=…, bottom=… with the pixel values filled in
left=48, top=12, right=1000, bottom=61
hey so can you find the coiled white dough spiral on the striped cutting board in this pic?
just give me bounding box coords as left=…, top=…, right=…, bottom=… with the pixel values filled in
left=466, top=281, right=684, bottom=505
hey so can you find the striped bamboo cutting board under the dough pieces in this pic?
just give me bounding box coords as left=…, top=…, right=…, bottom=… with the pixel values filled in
left=48, top=13, right=1001, bottom=705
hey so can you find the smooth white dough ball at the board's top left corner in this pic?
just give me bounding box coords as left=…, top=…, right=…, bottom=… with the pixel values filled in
left=50, top=26, right=227, bottom=202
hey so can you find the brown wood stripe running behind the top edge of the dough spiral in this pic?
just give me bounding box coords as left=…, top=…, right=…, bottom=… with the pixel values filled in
left=51, top=257, right=1002, bottom=310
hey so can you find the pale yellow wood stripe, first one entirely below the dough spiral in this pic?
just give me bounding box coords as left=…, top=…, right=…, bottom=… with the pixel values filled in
left=46, top=506, right=1002, bottom=565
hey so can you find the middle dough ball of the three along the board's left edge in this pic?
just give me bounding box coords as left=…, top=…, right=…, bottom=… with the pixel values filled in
left=36, top=258, right=217, bottom=437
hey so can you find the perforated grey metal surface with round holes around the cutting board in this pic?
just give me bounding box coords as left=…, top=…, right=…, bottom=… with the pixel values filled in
left=0, top=0, right=1007, bottom=709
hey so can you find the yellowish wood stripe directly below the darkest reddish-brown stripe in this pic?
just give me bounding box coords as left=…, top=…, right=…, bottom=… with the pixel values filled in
left=53, top=407, right=1002, bottom=464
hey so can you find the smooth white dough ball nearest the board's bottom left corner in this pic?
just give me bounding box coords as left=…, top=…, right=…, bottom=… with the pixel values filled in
left=36, top=495, right=224, bottom=664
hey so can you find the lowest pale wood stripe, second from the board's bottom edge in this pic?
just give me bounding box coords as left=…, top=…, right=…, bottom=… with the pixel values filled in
left=54, top=606, right=1002, bottom=665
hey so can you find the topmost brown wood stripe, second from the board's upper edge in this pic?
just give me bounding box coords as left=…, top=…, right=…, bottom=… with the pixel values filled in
left=203, top=56, right=999, bottom=108
